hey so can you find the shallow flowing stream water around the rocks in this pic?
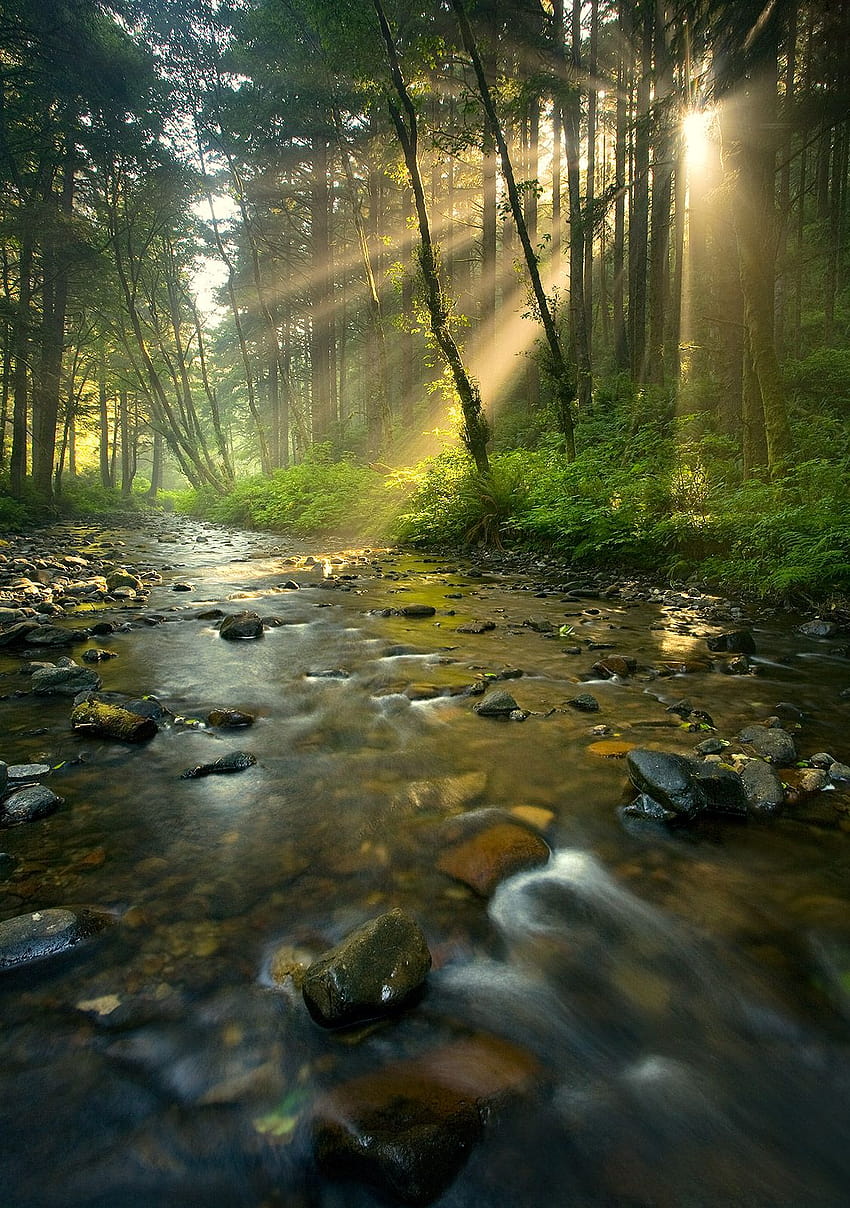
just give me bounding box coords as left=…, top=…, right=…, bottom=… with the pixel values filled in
left=0, top=529, right=850, bottom=1208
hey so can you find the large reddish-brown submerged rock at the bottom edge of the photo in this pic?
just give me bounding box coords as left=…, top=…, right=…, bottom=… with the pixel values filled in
left=312, top=1036, right=538, bottom=1206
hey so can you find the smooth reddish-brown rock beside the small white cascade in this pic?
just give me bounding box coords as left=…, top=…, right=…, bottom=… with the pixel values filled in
left=437, top=809, right=551, bottom=898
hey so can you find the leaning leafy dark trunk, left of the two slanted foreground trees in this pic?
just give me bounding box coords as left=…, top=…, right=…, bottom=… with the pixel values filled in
left=373, top=0, right=490, bottom=475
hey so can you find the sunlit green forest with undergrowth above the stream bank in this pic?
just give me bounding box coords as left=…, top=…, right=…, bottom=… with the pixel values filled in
left=0, top=0, right=850, bottom=602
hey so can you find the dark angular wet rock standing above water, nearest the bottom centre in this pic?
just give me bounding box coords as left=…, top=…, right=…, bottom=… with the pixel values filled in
left=302, top=910, right=431, bottom=1028
